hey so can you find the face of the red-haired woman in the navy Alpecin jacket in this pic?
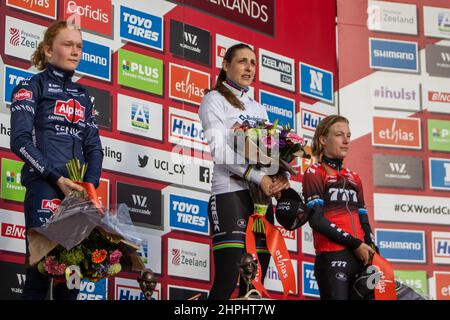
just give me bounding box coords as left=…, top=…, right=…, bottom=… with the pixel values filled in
left=44, top=28, right=83, bottom=71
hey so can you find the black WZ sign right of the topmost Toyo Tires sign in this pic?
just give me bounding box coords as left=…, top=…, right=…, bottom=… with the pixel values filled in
left=170, top=20, right=211, bottom=66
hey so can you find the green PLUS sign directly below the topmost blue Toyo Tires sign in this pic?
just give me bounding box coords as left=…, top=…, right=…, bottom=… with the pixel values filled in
left=118, top=49, right=164, bottom=95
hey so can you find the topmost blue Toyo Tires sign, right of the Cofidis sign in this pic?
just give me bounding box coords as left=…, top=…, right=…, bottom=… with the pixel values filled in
left=120, top=6, right=164, bottom=50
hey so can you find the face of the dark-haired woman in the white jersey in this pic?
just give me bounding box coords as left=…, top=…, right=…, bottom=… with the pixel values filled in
left=222, top=48, right=256, bottom=87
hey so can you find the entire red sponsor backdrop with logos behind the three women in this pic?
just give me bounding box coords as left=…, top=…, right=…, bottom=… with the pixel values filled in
left=0, top=0, right=450, bottom=300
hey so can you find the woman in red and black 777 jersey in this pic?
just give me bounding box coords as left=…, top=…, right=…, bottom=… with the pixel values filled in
left=303, top=115, right=374, bottom=300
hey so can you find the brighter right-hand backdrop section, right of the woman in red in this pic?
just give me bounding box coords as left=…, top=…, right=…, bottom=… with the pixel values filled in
left=338, top=0, right=450, bottom=300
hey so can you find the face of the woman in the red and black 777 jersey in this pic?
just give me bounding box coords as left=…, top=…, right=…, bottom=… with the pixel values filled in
left=320, top=122, right=351, bottom=159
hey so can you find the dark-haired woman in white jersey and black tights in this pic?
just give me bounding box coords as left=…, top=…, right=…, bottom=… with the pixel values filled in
left=199, top=43, right=289, bottom=299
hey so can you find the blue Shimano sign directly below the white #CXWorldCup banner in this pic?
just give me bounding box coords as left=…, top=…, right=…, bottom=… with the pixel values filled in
left=375, top=229, right=426, bottom=263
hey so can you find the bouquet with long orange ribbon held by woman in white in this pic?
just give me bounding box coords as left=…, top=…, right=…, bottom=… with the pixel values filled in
left=232, top=120, right=310, bottom=296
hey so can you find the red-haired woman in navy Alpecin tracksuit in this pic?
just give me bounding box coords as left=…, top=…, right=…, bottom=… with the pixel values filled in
left=11, top=21, right=103, bottom=300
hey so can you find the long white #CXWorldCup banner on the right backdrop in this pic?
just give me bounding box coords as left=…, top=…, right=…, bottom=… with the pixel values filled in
left=373, top=193, right=450, bottom=225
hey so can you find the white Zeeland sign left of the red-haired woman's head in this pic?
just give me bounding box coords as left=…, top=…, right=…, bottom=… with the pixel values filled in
left=5, top=16, right=45, bottom=60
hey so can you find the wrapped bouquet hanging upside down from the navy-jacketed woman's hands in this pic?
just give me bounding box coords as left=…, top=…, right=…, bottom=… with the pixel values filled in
left=28, top=160, right=145, bottom=286
